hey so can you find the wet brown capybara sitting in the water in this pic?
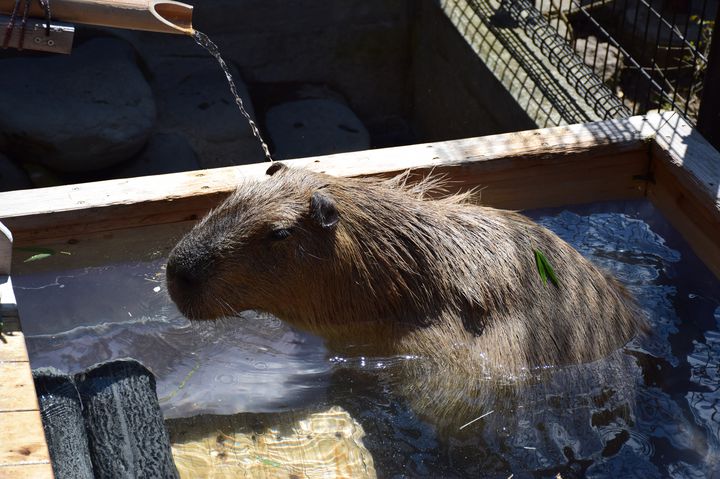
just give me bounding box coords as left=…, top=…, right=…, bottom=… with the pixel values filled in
left=167, top=163, right=645, bottom=372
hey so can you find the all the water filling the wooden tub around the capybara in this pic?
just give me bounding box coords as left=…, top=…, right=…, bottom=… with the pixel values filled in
left=14, top=201, right=720, bottom=478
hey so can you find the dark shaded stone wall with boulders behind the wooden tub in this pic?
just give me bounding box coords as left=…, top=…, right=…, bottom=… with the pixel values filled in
left=0, top=0, right=556, bottom=190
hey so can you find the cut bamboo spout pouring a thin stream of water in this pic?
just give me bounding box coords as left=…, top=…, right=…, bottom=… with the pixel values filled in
left=0, top=0, right=193, bottom=35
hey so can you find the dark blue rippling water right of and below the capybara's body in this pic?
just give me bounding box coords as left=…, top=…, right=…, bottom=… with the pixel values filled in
left=333, top=202, right=720, bottom=477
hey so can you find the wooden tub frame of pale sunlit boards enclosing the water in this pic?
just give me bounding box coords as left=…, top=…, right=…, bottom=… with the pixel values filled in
left=0, top=113, right=720, bottom=478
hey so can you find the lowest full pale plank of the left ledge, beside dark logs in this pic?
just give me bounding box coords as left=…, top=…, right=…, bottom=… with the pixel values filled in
left=0, top=411, right=50, bottom=467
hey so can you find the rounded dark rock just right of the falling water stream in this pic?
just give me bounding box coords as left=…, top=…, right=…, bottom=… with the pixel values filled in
left=265, top=98, right=370, bottom=159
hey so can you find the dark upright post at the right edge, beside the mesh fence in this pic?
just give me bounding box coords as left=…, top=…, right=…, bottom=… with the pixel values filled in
left=697, top=9, right=720, bottom=151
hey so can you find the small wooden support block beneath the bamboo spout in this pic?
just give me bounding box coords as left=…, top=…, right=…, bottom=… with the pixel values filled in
left=0, top=15, right=75, bottom=54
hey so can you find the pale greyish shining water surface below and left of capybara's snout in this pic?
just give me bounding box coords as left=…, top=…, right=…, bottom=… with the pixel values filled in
left=15, top=258, right=331, bottom=417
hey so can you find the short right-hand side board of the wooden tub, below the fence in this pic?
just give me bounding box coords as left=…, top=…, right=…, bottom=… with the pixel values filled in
left=648, top=114, right=720, bottom=278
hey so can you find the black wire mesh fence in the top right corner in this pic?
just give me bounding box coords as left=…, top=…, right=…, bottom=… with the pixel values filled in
left=528, top=0, right=720, bottom=123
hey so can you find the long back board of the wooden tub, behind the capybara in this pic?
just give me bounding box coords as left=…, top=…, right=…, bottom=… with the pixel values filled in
left=0, top=114, right=653, bottom=245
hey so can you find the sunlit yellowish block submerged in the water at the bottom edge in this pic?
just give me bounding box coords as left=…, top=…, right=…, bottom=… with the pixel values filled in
left=168, top=406, right=377, bottom=479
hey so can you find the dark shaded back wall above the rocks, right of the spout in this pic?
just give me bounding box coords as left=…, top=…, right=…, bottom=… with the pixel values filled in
left=195, top=0, right=417, bottom=135
